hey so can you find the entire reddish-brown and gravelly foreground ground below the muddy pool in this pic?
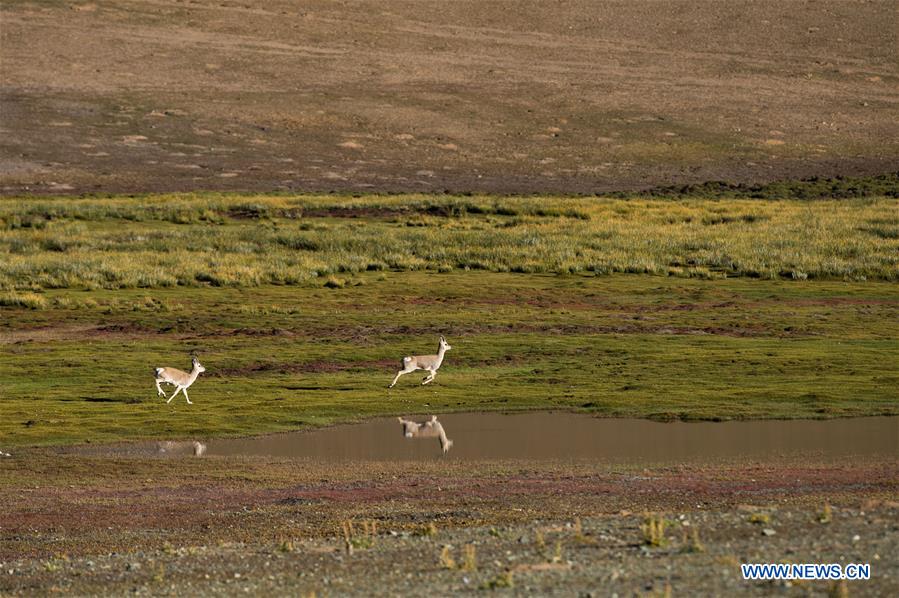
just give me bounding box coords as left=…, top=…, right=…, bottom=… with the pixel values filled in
left=0, top=450, right=899, bottom=596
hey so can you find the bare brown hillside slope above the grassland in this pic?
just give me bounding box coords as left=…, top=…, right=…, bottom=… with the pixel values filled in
left=0, top=0, right=899, bottom=195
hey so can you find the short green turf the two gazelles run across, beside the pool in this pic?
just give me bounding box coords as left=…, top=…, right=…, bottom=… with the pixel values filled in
left=0, top=271, right=899, bottom=447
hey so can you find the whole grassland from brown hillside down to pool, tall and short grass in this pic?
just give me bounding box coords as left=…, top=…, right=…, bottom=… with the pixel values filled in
left=0, top=196, right=899, bottom=446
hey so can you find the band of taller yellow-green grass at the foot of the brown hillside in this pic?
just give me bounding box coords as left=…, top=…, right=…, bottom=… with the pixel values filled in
left=0, top=194, right=899, bottom=292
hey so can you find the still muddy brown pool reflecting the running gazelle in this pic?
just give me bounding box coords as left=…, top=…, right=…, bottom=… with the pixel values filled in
left=200, top=413, right=899, bottom=463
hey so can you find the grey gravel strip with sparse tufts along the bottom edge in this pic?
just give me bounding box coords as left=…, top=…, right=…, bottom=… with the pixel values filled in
left=0, top=503, right=899, bottom=596
